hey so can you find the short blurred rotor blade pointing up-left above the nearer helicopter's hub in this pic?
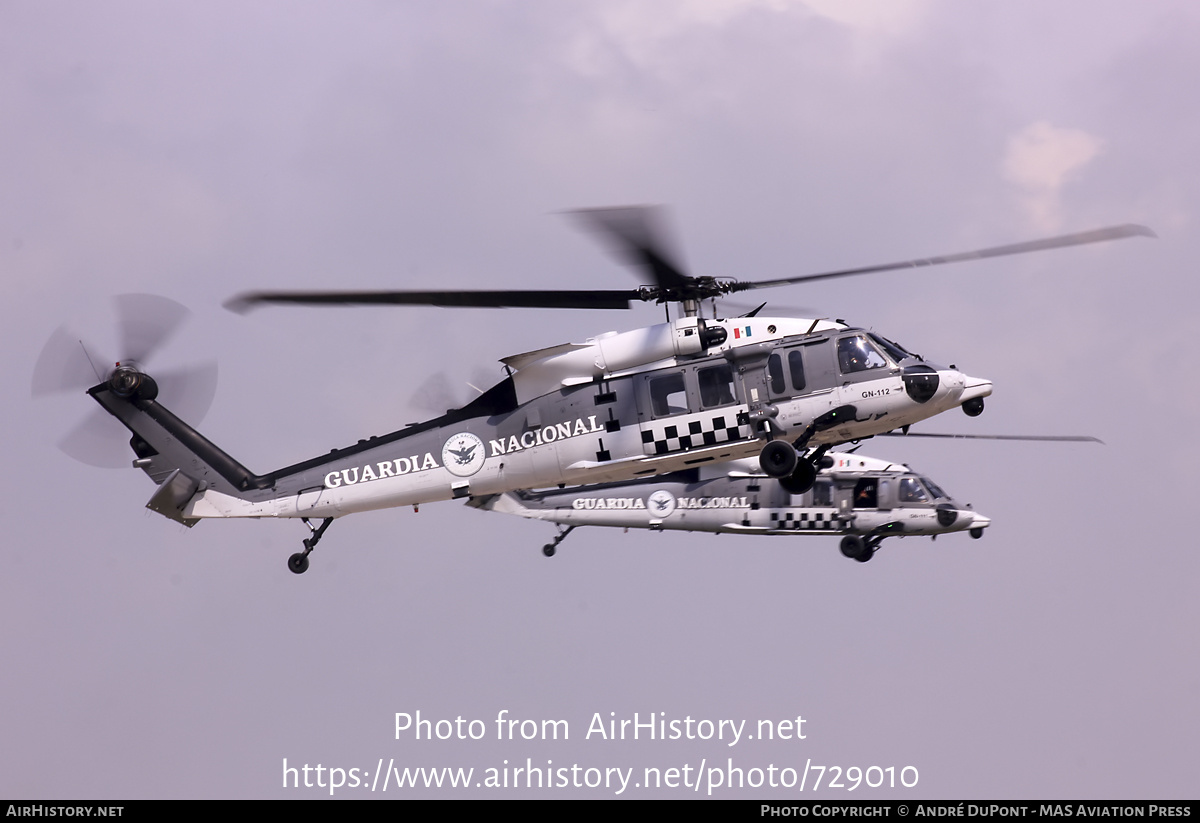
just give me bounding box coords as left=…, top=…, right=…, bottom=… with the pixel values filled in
left=566, top=206, right=692, bottom=289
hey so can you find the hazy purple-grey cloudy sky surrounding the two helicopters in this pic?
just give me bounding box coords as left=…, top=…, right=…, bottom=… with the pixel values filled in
left=0, top=0, right=1200, bottom=799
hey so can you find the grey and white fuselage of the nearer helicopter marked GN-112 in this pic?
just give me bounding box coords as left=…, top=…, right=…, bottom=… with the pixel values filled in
left=92, top=317, right=991, bottom=521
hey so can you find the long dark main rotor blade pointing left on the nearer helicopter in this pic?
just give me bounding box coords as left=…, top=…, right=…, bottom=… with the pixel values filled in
left=226, top=289, right=642, bottom=314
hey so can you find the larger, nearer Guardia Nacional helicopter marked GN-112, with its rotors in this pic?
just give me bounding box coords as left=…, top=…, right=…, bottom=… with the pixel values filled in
left=34, top=208, right=1153, bottom=573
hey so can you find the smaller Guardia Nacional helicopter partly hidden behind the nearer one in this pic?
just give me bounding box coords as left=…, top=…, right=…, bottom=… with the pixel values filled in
left=467, top=433, right=1100, bottom=563
